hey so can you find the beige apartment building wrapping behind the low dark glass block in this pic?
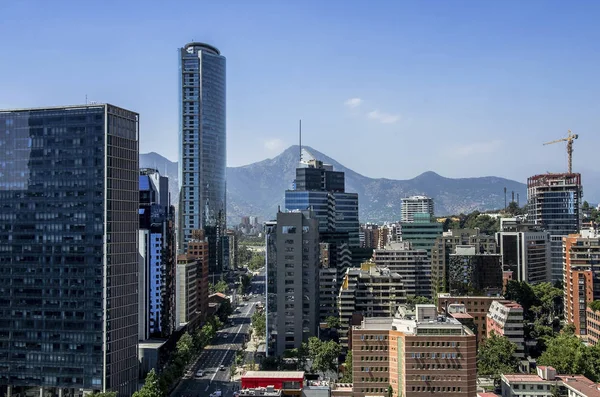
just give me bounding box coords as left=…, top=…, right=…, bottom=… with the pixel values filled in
left=431, top=229, right=496, bottom=296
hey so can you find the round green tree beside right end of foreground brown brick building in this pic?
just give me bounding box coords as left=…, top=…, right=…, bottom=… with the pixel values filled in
left=477, top=333, right=519, bottom=384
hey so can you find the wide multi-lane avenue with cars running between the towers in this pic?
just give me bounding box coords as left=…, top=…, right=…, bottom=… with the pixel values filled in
left=171, top=273, right=264, bottom=397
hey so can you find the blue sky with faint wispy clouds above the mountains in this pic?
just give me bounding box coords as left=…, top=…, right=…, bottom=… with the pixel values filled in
left=0, top=0, right=600, bottom=184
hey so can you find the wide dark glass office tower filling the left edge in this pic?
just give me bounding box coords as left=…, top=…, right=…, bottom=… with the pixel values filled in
left=0, top=104, right=139, bottom=396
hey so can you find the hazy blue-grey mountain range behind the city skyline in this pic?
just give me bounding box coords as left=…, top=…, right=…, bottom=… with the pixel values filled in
left=140, top=145, right=527, bottom=225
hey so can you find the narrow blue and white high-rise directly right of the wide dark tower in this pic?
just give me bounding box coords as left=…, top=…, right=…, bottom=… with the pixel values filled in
left=138, top=169, right=176, bottom=340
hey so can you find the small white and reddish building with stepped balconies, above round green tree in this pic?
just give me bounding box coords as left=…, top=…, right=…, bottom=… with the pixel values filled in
left=487, top=300, right=525, bottom=359
